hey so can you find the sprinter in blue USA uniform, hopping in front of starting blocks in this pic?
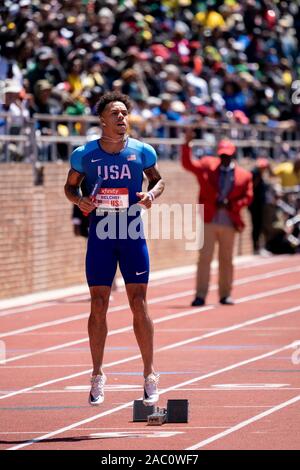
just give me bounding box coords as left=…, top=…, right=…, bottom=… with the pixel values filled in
left=65, top=92, right=165, bottom=406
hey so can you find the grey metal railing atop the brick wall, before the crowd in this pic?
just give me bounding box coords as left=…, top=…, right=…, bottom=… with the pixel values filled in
left=0, top=113, right=300, bottom=163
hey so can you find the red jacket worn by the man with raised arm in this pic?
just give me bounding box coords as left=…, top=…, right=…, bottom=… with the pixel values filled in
left=181, top=144, right=253, bottom=231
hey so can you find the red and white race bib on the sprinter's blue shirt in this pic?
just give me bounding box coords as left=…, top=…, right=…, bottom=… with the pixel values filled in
left=95, top=188, right=129, bottom=213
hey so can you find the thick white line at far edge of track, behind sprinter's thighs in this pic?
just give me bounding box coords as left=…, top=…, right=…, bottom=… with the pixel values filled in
left=0, top=255, right=289, bottom=317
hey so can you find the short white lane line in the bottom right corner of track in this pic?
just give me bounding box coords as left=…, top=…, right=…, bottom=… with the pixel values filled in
left=185, top=395, right=300, bottom=450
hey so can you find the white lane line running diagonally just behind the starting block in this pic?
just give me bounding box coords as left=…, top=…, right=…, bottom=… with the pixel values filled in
left=6, top=344, right=293, bottom=450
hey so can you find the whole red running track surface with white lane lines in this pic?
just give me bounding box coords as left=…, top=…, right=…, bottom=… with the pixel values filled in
left=0, top=256, right=300, bottom=451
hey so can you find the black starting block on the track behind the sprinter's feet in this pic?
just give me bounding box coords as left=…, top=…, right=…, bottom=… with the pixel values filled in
left=133, top=400, right=189, bottom=426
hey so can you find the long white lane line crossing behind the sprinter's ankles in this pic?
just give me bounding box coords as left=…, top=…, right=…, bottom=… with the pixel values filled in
left=0, top=306, right=300, bottom=400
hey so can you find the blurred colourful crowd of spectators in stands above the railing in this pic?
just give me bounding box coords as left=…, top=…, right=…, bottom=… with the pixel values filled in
left=0, top=0, right=300, bottom=140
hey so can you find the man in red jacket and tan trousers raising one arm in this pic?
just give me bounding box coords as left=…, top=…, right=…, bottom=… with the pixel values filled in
left=182, top=131, right=253, bottom=306
